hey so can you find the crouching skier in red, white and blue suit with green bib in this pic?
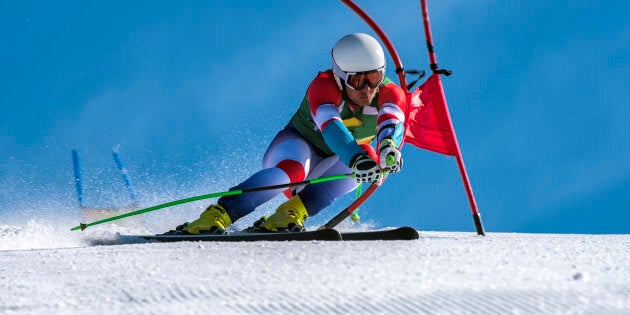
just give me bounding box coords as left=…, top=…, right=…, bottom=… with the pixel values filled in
left=173, top=33, right=406, bottom=234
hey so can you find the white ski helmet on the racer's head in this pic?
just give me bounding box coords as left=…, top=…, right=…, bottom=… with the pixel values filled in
left=332, top=33, right=385, bottom=88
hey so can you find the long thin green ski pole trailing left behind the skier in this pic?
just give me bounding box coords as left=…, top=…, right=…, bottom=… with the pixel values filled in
left=70, top=173, right=353, bottom=231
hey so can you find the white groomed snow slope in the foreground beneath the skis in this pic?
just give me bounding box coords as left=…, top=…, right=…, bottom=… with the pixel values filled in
left=0, top=222, right=630, bottom=314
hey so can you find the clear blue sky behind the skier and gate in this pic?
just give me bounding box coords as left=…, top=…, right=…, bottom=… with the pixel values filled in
left=0, top=0, right=630, bottom=233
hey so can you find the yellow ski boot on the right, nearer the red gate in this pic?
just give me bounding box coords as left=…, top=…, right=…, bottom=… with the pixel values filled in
left=259, top=196, right=308, bottom=232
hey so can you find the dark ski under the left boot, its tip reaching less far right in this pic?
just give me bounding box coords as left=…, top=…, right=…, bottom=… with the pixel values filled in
left=135, top=229, right=341, bottom=242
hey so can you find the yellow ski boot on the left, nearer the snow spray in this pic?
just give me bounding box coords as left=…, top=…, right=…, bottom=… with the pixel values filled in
left=166, top=205, right=232, bottom=234
